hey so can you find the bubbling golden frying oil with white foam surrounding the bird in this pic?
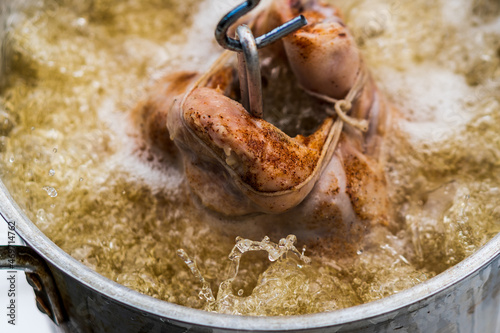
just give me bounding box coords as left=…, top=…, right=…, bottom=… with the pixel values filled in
left=0, top=0, right=500, bottom=315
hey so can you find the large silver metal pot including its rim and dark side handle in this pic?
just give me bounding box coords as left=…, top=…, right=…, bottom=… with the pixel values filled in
left=0, top=1, right=500, bottom=333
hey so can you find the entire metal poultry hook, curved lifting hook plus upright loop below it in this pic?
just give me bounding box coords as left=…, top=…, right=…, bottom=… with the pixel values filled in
left=215, top=0, right=307, bottom=118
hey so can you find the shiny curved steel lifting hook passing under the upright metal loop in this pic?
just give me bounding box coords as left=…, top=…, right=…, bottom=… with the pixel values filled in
left=215, top=0, right=307, bottom=52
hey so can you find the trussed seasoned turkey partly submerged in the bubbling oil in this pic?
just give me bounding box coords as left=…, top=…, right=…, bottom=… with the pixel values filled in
left=134, top=0, right=391, bottom=256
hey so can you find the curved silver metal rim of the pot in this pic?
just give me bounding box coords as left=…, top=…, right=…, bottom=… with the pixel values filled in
left=0, top=180, right=500, bottom=331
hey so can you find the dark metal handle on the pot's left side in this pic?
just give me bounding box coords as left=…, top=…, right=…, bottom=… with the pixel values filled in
left=0, top=245, right=65, bottom=325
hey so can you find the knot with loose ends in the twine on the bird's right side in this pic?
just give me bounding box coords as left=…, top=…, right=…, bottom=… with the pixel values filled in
left=306, top=70, right=369, bottom=132
